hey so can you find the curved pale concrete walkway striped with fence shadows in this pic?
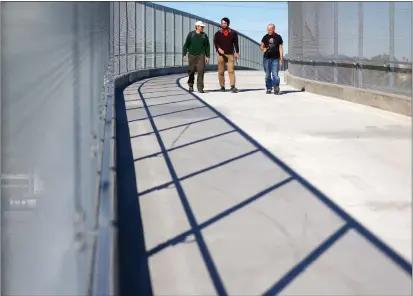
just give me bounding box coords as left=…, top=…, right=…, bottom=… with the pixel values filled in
left=116, top=71, right=411, bottom=295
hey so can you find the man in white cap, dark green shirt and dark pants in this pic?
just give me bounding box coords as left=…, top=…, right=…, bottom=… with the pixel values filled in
left=182, top=21, right=210, bottom=93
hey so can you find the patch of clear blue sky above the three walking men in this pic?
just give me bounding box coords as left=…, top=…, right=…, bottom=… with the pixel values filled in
left=154, top=2, right=288, bottom=50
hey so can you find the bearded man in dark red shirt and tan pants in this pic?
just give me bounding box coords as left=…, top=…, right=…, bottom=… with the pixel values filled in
left=214, top=17, right=239, bottom=93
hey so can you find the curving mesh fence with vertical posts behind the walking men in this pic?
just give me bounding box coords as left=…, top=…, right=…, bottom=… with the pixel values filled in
left=111, top=2, right=263, bottom=76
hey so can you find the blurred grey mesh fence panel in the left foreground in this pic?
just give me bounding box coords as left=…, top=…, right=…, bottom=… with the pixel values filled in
left=1, top=2, right=113, bottom=295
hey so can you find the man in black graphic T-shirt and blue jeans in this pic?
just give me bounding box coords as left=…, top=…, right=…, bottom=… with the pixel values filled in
left=260, top=24, right=283, bottom=94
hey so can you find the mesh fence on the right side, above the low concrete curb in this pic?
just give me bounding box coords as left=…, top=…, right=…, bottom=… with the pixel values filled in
left=287, top=2, right=412, bottom=97
